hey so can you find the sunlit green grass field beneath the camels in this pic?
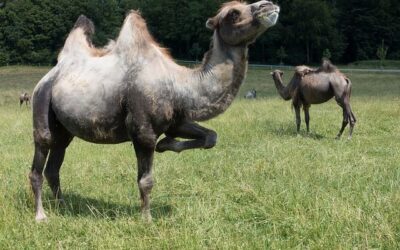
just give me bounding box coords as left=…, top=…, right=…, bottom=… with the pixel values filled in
left=0, top=67, right=400, bottom=249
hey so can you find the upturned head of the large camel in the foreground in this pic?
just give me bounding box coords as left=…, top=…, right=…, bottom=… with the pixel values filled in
left=206, top=1, right=280, bottom=46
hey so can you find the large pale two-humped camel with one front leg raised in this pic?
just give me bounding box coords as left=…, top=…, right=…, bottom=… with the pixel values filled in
left=30, top=1, right=279, bottom=221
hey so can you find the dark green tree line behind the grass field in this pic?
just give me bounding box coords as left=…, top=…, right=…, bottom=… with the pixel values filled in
left=0, top=0, right=400, bottom=65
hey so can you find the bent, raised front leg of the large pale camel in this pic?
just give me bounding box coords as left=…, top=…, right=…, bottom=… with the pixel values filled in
left=156, top=122, right=217, bottom=153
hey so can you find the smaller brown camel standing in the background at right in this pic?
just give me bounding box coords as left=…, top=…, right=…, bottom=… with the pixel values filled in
left=271, top=60, right=356, bottom=139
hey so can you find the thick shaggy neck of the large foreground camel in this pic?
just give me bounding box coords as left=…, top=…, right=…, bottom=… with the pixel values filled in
left=185, top=34, right=247, bottom=121
